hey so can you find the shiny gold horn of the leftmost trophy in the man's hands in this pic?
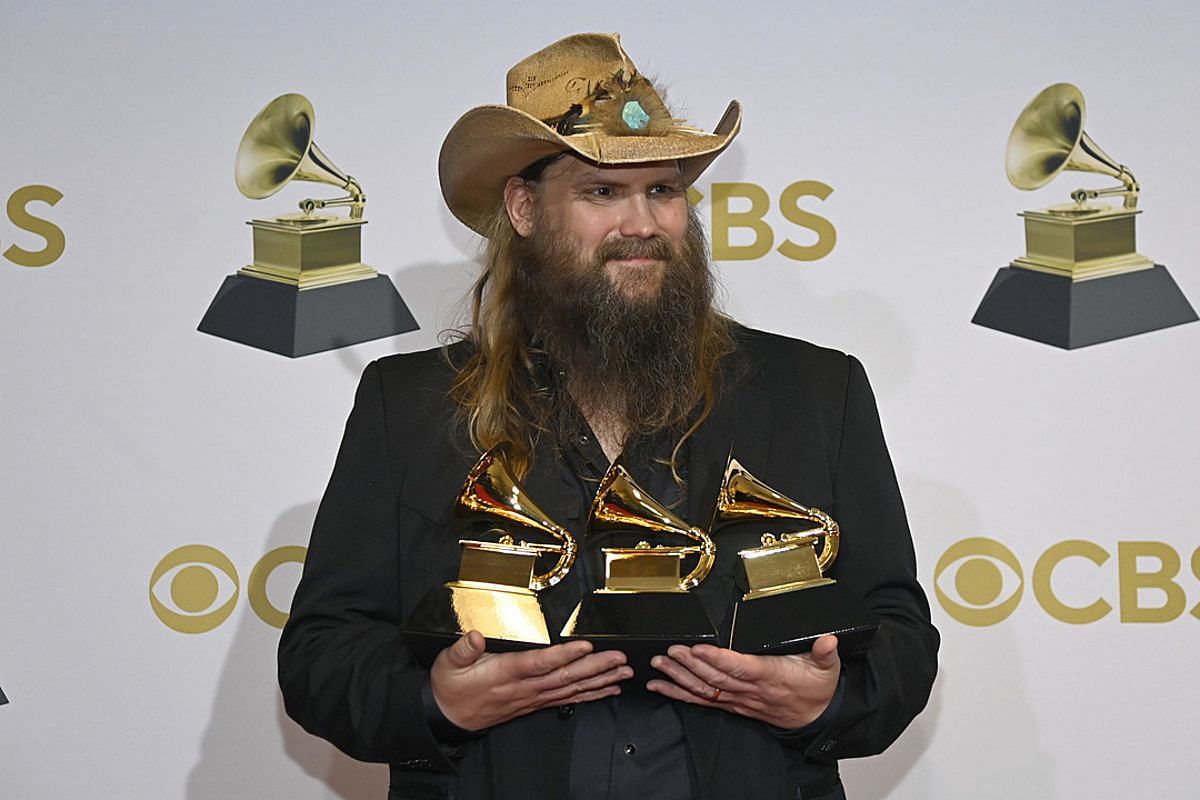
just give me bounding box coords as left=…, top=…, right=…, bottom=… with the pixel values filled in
left=455, top=450, right=577, bottom=591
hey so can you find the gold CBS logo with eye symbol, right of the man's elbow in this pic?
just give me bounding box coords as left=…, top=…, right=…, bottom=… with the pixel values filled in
left=934, top=536, right=1200, bottom=627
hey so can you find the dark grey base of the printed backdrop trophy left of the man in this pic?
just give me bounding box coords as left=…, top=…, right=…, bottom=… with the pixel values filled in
left=198, top=275, right=419, bottom=359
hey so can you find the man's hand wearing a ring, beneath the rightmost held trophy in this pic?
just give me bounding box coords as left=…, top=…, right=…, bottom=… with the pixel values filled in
left=646, top=636, right=841, bottom=729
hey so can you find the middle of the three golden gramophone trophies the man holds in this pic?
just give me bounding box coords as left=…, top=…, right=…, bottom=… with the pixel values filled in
left=562, top=461, right=716, bottom=691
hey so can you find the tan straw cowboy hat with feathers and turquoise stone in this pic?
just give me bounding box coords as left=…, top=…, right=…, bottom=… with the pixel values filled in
left=438, top=34, right=742, bottom=235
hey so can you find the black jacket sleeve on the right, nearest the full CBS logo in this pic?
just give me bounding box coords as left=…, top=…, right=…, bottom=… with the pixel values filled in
left=805, top=356, right=940, bottom=762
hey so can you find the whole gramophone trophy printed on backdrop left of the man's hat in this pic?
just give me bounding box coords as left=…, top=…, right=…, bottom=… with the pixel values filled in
left=199, top=95, right=416, bottom=357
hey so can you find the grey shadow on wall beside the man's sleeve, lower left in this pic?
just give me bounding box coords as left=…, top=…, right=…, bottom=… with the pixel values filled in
left=186, top=503, right=388, bottom=800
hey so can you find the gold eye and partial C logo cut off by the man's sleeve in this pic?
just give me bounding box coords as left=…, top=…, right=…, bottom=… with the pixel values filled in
left=150, top=545, right=308, bottom=633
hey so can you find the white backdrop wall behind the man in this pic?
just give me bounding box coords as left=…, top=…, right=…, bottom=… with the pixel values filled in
left=0, top=1, right=1200, bottom=800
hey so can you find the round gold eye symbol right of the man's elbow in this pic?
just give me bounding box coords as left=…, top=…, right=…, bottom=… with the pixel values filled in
left=934, top=536, right=1025, bottom=627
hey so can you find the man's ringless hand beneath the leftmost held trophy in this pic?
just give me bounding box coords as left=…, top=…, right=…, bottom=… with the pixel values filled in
left=430, top=631, right=634, bottom=730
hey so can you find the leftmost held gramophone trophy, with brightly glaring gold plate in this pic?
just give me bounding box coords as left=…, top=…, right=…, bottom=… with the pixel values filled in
left=402, top=451, right=577, bottom=667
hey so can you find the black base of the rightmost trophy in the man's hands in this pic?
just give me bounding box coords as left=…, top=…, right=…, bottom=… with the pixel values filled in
left=730, top=583, right=880, bottom=658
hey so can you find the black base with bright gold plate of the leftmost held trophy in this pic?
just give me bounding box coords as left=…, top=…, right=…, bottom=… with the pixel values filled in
left=401, top=583, right=550, bottom=669
